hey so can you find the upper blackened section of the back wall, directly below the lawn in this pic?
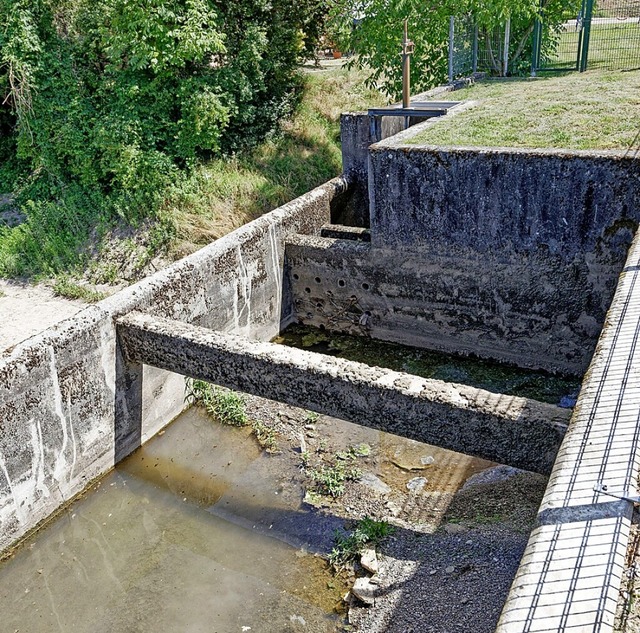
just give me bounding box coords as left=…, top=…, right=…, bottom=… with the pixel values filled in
left=370, top=146, right=640, bottom=254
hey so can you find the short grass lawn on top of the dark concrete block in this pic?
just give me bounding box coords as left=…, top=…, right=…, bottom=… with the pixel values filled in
left=408, top=71, right=640, bottom=150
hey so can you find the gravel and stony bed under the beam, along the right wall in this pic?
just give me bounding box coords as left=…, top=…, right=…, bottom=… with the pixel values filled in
left=239, top=398, right=546, bottom=633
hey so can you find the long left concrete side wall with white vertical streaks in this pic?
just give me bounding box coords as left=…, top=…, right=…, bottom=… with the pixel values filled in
left=0, top=178, right=346, bottom=551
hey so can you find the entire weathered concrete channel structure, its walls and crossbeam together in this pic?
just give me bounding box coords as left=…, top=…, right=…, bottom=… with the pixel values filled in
left=0, top=96, right=640, bottom=633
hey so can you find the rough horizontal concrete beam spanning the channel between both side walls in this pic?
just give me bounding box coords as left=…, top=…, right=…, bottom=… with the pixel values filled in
left=117, top=313, right=570, bottom=473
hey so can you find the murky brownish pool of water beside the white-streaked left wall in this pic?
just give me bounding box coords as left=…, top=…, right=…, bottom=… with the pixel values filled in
left=0, top=409, right=342, bottom=633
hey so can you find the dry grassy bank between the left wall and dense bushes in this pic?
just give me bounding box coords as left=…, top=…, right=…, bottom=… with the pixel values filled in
left=164, top=63, right=383, bottom=257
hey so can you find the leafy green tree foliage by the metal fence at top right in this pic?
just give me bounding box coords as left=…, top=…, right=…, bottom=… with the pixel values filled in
left=329, top=0, right=579, bottom=98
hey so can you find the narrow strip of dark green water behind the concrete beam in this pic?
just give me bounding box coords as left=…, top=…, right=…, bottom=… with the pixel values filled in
left=275, top=325, right=580, bottom=406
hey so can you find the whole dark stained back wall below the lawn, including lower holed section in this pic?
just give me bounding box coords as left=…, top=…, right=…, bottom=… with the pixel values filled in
left=287, top=133, right=640, bottom=375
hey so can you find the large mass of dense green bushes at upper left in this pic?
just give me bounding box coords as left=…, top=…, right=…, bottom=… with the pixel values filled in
left=0, top=0, right=323, bottom=275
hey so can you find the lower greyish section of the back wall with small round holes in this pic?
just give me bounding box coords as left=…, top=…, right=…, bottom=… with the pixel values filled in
left=286, top=236, right=616, bottom=375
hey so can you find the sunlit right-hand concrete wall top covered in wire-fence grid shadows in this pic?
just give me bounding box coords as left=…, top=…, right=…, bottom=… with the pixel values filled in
left=497, top=234, right=640, bottom=633
